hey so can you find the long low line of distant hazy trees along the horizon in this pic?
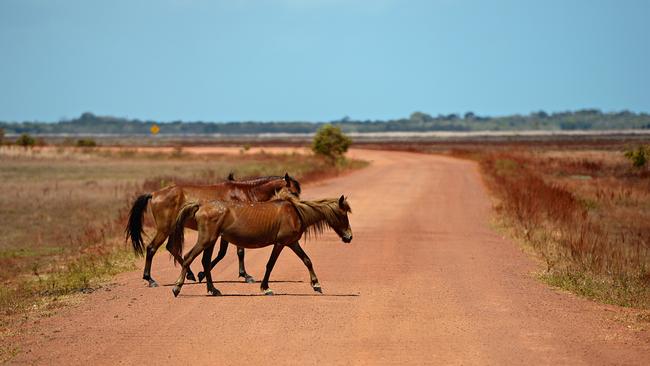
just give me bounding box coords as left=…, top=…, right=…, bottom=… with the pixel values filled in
left=0, top=109, right=650, bottom=135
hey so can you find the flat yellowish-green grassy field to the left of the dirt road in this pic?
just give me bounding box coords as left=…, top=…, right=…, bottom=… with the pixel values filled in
left=0, top=147, right=364, bottom=342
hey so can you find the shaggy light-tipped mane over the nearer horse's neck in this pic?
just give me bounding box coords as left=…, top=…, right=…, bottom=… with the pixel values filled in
left=273, top=189, right=352, bottom=236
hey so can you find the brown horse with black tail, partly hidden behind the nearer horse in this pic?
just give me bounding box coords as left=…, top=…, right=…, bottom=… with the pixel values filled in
left=125, top=173, right=300, bottom=287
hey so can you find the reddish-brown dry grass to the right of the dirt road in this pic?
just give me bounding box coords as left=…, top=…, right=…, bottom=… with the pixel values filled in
left=455, top=148, right=650, bottom=309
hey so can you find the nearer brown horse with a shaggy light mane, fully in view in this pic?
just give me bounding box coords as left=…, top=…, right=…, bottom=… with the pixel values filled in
left=169, top=191, right=352, bottom=296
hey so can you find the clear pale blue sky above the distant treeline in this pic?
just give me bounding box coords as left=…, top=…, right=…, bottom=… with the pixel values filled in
left=0, top=0, right=650, bottom=121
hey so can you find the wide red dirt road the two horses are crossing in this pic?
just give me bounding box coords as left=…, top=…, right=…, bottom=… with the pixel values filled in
left=11, top=150, right=650, bottom=365
